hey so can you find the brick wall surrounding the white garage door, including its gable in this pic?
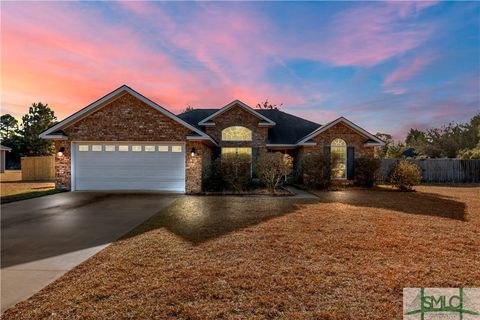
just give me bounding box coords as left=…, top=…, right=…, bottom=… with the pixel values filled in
left=55, top=94, right=210, bottom=193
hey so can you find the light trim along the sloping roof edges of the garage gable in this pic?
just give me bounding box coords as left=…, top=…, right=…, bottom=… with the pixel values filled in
left=40, top=85, right=215, bottom=143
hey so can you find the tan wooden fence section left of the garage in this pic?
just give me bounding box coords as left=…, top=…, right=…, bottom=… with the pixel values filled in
left=22, top=156, right=55, bottom=181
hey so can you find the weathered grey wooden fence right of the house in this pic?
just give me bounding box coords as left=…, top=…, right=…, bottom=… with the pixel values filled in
left=380, top=159, right=480, bottom=183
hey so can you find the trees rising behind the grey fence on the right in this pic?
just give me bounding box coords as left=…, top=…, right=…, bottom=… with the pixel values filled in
left=376, top=113, right=480, bottom=159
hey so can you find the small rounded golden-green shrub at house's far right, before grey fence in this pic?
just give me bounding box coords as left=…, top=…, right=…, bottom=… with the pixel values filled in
left=388, top=160, right=422, bottom=191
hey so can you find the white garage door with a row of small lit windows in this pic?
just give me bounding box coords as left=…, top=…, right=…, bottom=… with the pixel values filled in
left=72, top=142, right=185, bottom=192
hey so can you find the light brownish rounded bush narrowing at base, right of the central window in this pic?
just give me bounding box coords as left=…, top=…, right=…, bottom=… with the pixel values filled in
left=257, top=152, right=293, bottom=193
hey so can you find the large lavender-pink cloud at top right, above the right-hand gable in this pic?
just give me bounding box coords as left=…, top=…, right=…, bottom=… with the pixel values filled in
left=294, top=2, right=433, bottom=67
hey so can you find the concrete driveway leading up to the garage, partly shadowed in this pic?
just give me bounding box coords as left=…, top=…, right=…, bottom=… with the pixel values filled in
left=1, top=192, right=179, bottom=312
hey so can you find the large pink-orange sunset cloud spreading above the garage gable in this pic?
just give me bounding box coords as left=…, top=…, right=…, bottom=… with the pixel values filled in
left=2, top=4, right=304, bottom=119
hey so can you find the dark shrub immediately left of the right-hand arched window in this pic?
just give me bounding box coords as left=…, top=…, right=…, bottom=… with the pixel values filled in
left=300, top=154, right=331, bottom=189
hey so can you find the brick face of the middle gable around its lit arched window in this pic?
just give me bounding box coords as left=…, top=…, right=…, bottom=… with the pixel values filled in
left=205, top=106, right=268, bottom=149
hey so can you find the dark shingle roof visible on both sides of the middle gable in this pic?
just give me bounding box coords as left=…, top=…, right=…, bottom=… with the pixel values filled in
left=178, top=109, right=320, bottom=144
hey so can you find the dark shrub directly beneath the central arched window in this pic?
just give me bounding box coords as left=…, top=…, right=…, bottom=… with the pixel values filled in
left=220, top=154, right=252, bottom=192
